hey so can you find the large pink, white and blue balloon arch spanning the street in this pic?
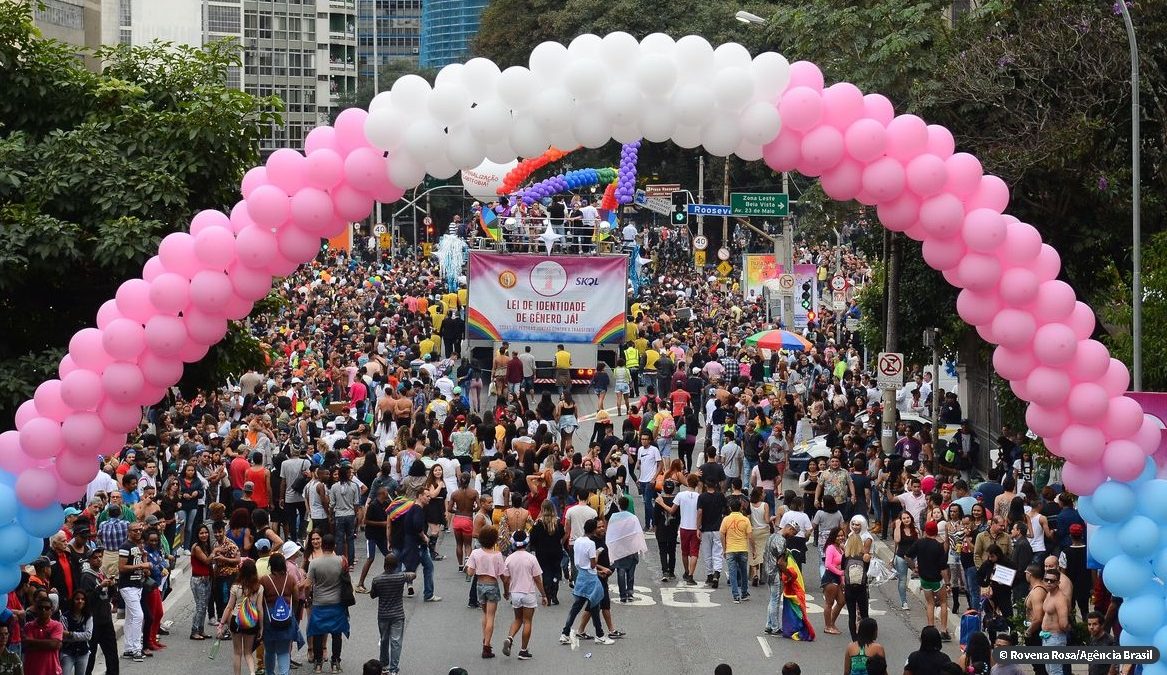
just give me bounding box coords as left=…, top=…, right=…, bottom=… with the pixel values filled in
left=0, top=33, right=1167, bottom=658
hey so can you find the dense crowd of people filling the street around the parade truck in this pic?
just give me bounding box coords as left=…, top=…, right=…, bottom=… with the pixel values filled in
left=0, top=211, right=1119, bottom=675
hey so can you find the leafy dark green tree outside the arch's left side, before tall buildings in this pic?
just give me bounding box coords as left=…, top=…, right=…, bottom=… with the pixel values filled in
left=0, top=2, right=281, bottom=416
